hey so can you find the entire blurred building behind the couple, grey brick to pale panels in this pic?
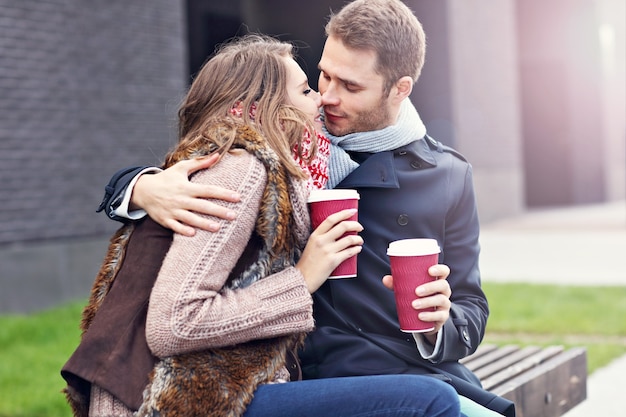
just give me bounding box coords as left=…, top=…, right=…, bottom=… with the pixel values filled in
left=0, top=0, right=626, bottom=313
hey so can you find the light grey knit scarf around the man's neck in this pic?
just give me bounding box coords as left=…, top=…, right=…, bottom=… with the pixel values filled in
left=324, top=98, right=426, bottom=188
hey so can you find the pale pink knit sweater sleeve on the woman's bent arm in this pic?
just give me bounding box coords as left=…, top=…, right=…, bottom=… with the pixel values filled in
left=146, top=152, right=313, bottom=357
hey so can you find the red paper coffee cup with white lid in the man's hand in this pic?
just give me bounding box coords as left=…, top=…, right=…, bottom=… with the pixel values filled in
left=387, top=239, right=440, bottom=333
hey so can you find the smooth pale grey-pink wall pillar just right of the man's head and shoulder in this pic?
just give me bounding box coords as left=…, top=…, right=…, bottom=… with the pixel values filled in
left=449, top=0, right=525, bottom=223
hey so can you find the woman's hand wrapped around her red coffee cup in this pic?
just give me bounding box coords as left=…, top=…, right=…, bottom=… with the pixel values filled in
left=296, top=209, right=363, bottom=294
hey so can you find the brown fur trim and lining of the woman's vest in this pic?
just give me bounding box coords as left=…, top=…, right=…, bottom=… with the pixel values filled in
left=66, top=126, right=305, bottom=417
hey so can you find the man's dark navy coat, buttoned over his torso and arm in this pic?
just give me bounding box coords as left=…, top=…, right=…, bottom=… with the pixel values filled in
left=301, top=137, right=514, bottom=415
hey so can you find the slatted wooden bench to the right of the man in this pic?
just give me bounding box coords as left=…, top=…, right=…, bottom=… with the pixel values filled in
left=461, top=345, right=587, bottom=417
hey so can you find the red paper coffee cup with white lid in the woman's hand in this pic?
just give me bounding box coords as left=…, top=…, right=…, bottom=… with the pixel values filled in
left=309, top=189, right=359, bottom=278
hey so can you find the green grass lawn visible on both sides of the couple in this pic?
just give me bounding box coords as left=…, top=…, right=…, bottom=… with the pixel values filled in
left=0, top=283, right=626, bottom=417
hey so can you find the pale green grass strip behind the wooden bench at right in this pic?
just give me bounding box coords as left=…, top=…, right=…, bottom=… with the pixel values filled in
left=483, top=283, right=626, bottom=373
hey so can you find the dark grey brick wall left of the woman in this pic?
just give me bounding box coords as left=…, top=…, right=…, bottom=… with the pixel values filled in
left=0, top=0, right=187, bottom=312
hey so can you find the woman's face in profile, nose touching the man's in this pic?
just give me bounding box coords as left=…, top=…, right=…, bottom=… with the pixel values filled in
left=284, top=57, right=322, bottom=130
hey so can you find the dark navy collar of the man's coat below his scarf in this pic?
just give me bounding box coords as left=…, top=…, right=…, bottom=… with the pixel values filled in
left=337, top=136, right=438, bottom=188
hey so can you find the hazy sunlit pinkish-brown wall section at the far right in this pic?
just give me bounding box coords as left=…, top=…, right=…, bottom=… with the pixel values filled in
left=517, top=0, right=626, bottom=207
